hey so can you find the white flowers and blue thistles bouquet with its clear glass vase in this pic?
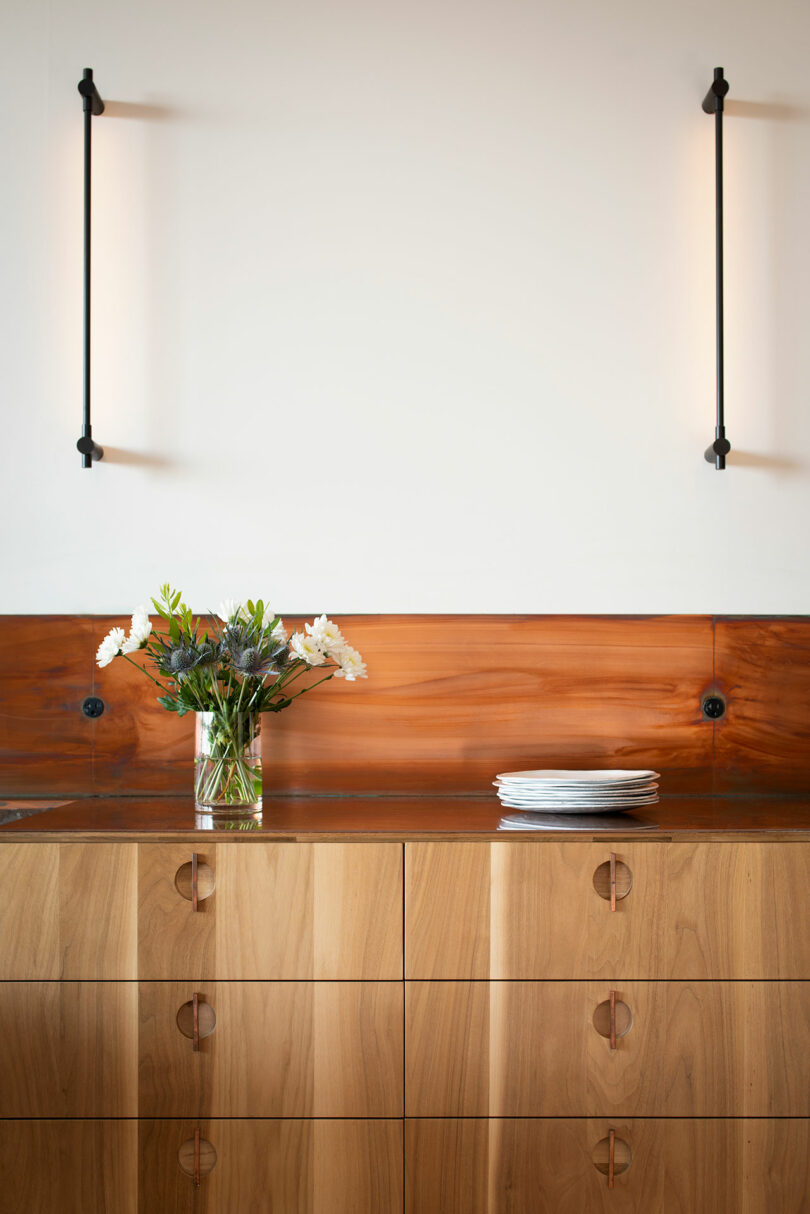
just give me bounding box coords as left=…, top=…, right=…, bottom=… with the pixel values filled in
left=96, top=585, right=366, bottom=812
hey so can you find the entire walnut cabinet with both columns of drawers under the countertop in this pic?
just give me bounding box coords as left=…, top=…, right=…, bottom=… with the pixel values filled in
left=0, top=828, right=810, bottom=1214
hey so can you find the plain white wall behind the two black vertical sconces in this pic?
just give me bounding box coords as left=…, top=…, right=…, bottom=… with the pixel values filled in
left=0, top=0, right=810, bottom=613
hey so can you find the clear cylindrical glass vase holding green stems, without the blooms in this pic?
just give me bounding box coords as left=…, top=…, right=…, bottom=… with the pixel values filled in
left=194, top=710, right=261, bottom=813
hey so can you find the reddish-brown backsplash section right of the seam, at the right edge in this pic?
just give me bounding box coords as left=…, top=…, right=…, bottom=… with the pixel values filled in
left=714, top=617, right=810, bottom=793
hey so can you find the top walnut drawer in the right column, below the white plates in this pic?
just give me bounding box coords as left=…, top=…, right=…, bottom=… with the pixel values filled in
left=406, top=841, right=810, bottom=980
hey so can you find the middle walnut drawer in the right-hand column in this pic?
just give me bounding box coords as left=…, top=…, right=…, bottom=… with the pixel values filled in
left=406, top=982, right=810, bottom=1117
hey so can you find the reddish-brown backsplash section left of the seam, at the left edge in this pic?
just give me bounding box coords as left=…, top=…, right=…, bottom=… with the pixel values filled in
left=0, top=615, right=94, bottom=796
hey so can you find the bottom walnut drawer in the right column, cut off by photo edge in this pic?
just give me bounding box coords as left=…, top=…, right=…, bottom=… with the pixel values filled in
left=406, top=1119, right=810, bottom=1214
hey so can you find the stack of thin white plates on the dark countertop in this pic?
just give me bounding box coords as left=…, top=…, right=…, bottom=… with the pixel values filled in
left=494, top=767, right=659, bottom=813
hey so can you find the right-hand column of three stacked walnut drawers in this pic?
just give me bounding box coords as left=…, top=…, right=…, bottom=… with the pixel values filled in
left=406, top=839, right=810, bottom=1214
